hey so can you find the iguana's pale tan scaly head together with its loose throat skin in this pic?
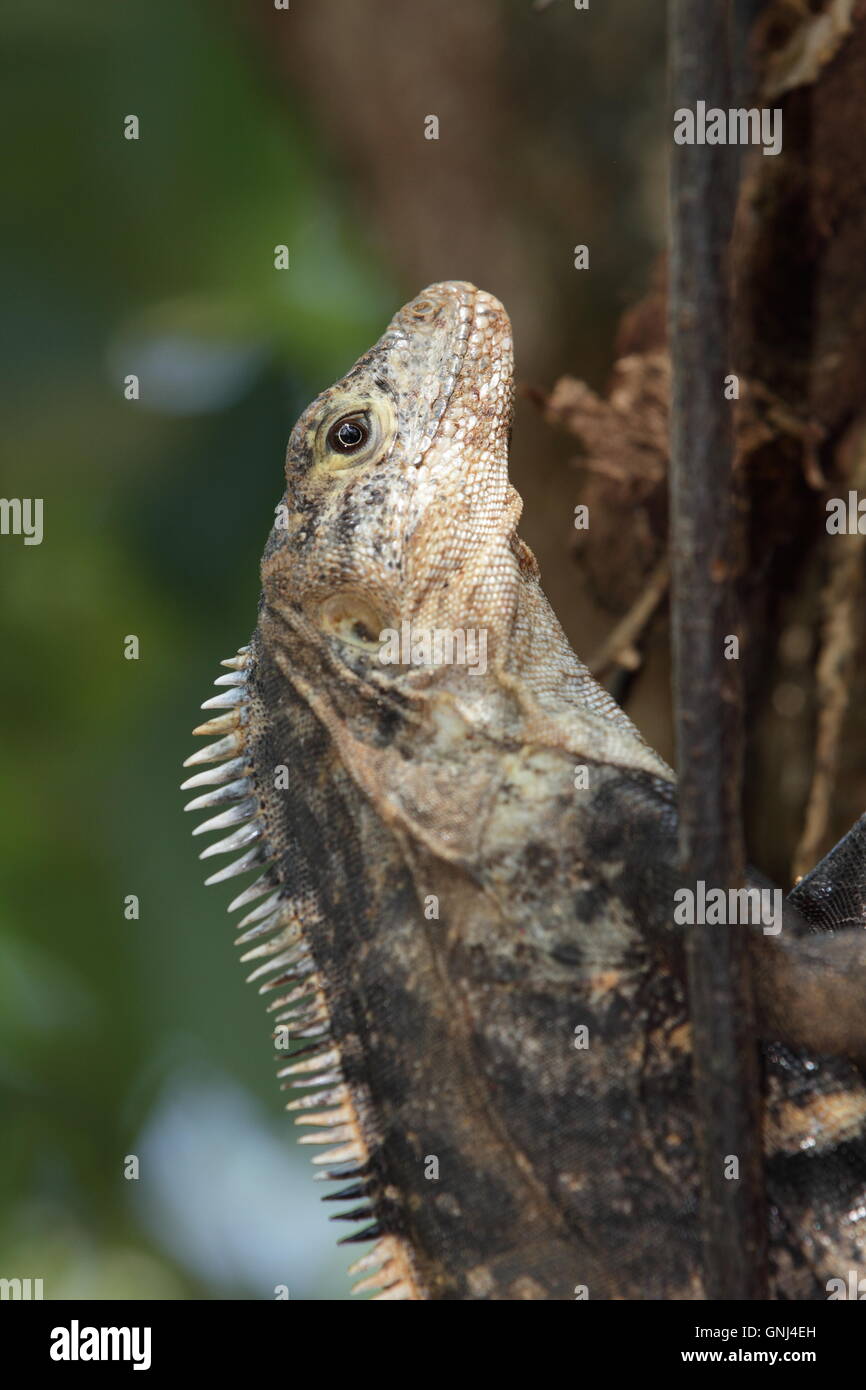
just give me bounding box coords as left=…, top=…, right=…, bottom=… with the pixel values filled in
left=260, top=281, right=670, bottom=787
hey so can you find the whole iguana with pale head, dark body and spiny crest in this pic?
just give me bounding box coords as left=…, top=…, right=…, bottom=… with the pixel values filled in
left=183, top=282, right=866, bottom=1300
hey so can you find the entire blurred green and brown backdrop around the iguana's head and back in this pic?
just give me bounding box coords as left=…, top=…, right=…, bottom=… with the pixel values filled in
left=0, top=0, right=669, bottom=1298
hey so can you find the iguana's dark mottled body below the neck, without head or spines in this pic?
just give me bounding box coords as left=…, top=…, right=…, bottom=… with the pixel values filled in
left=241, top=614, right=866, bottom=1300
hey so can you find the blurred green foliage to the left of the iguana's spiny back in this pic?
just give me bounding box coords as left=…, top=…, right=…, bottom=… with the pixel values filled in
left=0, top=0, right=395, bottom=1298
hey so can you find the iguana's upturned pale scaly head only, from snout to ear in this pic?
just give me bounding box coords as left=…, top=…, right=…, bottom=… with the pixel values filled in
left=261, top=281, right=520, bottom=676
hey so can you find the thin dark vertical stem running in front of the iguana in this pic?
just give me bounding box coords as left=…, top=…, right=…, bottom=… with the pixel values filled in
left=669, top=0, right=766, bottom=1298
